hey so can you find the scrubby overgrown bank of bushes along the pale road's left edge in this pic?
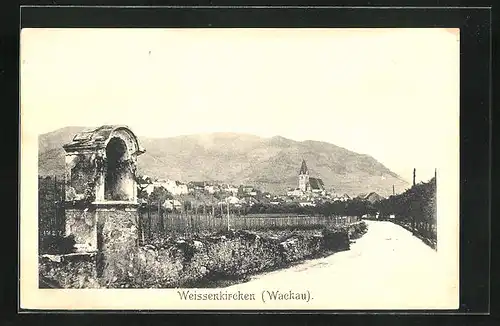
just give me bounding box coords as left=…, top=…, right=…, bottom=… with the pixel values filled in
left=41, top=222, right=366, bottom=288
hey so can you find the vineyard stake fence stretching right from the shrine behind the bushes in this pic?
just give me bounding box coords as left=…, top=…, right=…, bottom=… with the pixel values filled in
left=139, top=206, right=358, bottom=240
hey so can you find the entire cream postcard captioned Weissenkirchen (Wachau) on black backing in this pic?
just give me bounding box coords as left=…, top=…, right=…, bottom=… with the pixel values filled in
left=20, top=28, right=460, bottom=310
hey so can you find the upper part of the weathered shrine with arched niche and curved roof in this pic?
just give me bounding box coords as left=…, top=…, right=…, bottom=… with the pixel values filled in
left=64, top=126, right=144, bottom=202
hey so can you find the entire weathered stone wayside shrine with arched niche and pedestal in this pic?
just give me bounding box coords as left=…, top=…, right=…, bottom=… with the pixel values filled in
left=63, top=125, right=145, bottom=282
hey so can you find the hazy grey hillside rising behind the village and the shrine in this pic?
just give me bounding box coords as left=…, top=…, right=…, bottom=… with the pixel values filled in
left=39, top=127, right=409, bottom=196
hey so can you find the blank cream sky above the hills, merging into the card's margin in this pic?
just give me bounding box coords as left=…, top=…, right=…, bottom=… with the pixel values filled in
left=20, top=28, right=460, bottom=181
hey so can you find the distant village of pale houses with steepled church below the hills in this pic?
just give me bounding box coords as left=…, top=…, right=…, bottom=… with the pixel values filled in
left=138, top=160, right=384, bottom=212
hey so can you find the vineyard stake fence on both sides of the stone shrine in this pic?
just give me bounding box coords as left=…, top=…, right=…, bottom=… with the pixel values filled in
left=38, top=176, right=357, bottom=248
